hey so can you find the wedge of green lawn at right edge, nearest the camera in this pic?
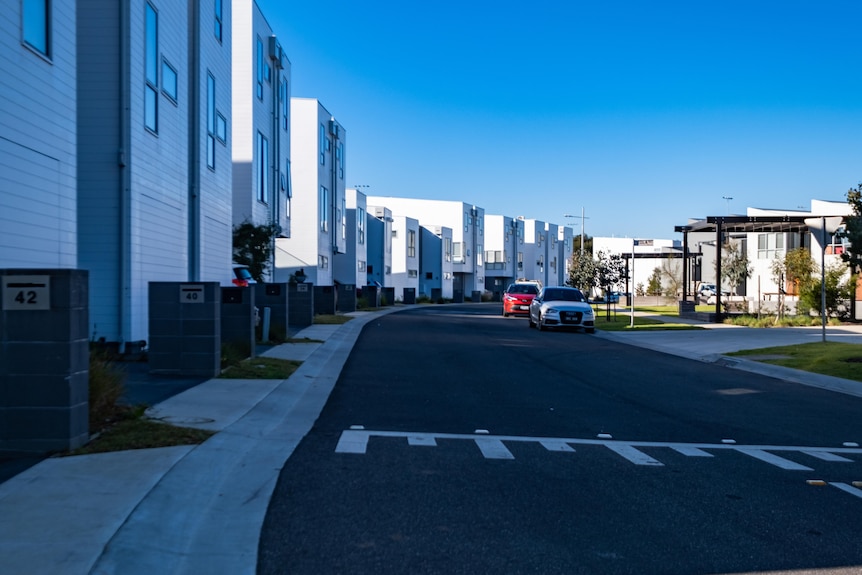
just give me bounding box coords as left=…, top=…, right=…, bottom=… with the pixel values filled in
left=725, top=341, right=862, bottom=381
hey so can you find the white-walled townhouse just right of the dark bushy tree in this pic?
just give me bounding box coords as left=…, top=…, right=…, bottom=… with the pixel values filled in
left=275, top=98, right=347, bottom=286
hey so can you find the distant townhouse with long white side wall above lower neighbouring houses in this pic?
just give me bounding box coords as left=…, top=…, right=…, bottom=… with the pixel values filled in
left=368, top=196, right=485, bottom=301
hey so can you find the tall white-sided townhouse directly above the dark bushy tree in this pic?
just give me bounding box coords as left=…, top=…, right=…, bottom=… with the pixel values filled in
left=231, top=0, right=291, bottom=264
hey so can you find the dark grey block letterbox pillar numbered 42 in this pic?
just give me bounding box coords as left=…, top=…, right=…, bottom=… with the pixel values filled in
left=0, top=269, right=90, bottom=453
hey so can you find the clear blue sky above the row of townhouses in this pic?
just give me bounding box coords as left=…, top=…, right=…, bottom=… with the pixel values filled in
left=258, top=0, right=862, bottom=239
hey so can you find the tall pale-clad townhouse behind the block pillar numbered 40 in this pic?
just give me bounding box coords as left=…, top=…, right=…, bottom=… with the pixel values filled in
left=77, top=0, right=232, bottom=342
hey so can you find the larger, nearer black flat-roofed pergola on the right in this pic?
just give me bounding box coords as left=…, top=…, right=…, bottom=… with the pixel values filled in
left=674, top=214, right=836, bottom=318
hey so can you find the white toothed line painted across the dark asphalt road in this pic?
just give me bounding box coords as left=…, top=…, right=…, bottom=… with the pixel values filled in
left=335, top=429, right=862, bottom=474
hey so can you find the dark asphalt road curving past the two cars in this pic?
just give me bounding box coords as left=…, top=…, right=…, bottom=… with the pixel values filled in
left=258, top=305, right=862, bottom=574
